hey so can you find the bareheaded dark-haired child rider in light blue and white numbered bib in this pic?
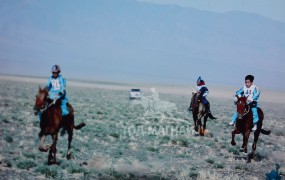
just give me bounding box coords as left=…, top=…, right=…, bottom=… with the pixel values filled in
left=229, top=75, right=260, bottom=131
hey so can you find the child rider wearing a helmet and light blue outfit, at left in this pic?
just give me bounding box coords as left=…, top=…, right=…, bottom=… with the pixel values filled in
left=39, top=65, right=69, bottom=136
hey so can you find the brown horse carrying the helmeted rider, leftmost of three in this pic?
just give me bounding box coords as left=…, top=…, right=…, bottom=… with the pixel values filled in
left=34, top=87, right=85, bottom=164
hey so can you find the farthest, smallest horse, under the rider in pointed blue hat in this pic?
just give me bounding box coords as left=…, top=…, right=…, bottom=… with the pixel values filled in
left=190, top=92, right=216, bottom=136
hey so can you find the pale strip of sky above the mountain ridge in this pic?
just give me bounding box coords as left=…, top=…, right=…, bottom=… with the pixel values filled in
left=139, top=0, right=285, bottom=22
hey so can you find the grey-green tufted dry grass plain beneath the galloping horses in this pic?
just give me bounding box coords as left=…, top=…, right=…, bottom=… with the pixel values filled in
left=0, top=76, right=285, bottom=179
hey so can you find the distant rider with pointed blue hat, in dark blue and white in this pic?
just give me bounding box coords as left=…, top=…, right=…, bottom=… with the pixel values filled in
left=188, top=76, right=211, bottom=113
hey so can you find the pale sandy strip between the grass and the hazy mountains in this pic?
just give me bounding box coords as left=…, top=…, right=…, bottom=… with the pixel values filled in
left=0, top=75, right=285, bottom=103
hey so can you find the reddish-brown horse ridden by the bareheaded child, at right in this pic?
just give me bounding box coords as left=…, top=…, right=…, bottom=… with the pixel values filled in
left=231, top=96, right=271, bottom=163
